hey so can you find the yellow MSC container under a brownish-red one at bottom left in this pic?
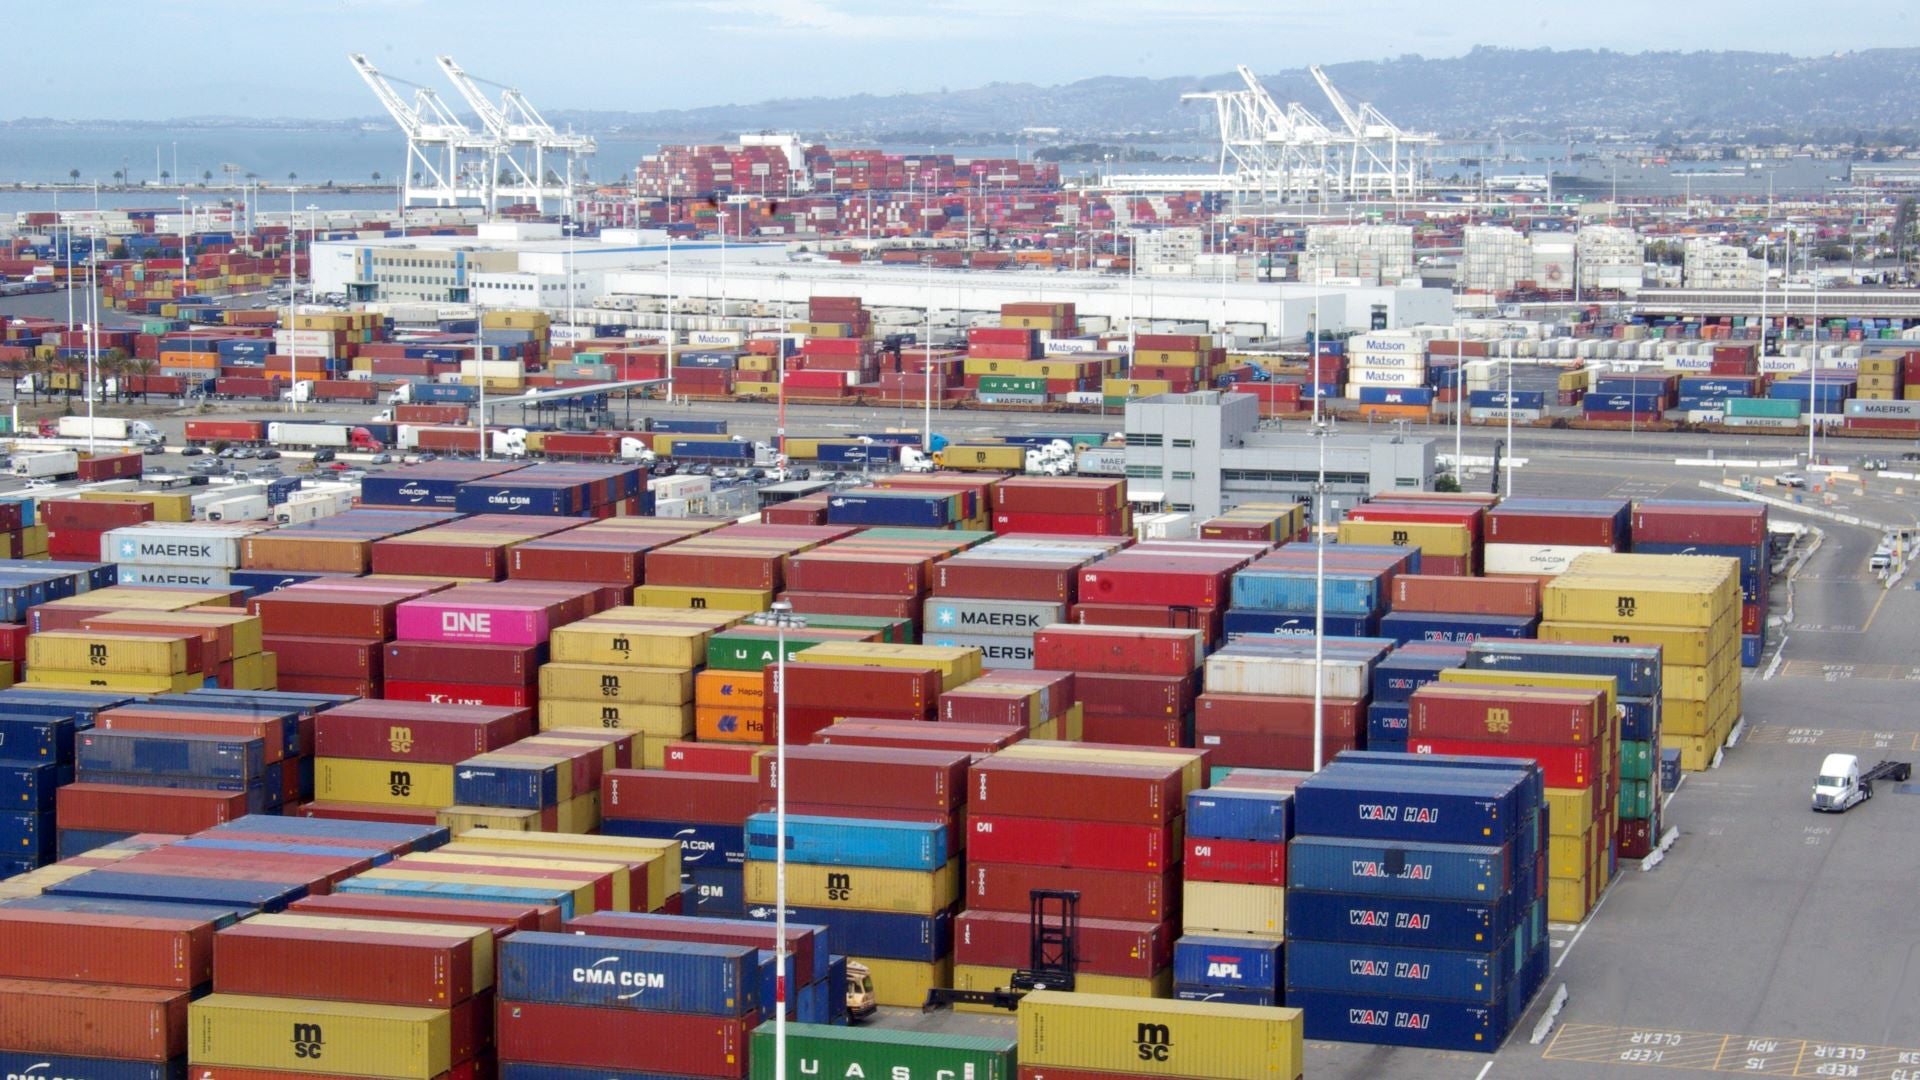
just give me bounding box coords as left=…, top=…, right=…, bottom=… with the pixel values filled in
left=186, top=994, right=453, bottom=1080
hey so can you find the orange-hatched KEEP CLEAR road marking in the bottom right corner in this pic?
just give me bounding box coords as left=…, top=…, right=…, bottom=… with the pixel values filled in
left=1542, top=1024, right=1920, bottom=1080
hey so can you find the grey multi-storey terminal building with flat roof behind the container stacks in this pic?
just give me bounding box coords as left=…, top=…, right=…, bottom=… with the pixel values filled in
left=1127, top=390, right=1434, bottom=525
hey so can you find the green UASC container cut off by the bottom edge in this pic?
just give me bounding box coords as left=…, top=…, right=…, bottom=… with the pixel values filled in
left=747, top=1024, right=1016, bottom=1080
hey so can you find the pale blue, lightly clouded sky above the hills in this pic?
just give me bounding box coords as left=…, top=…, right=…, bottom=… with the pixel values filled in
left=0, top=0, right=1920, bottom=119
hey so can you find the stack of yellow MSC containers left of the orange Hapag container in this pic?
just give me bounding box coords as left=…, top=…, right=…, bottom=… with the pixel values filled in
left=556, top=607, right=741, bottom=769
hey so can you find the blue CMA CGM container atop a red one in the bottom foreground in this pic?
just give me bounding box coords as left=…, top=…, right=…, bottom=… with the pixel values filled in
left=495, top=932, right=760, bottom=1019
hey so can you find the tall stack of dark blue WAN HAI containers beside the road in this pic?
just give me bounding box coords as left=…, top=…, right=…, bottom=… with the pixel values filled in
left=1286, top=753, right=1549, bottom=1053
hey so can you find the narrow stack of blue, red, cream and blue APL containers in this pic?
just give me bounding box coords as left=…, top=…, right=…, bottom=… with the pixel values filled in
left=1173, top=769, right=1296, bottom=1005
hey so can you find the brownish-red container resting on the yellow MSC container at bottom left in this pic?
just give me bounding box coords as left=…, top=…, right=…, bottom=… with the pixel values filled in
left=213, top=922, right=476, bottom=1009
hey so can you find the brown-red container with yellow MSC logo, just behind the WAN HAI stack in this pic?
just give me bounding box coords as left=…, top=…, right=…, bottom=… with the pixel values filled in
left=1407, top=682, right=1607, bottom=746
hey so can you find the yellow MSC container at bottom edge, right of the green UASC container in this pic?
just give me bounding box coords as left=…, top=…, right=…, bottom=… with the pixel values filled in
left=1018, top=990, right=1304, bottom=1080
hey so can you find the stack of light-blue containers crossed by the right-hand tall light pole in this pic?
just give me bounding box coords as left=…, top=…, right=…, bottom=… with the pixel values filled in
left=1221, top=544, right=1421, bottom=638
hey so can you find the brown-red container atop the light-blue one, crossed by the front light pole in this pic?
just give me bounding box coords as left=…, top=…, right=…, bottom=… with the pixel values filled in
left=760, top=745, right=972, bottom=813
